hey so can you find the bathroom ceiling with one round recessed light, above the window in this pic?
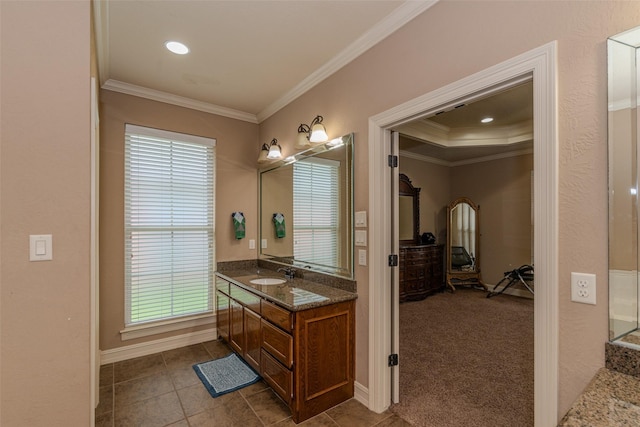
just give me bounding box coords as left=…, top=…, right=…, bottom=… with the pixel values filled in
left=94, top=0, right=437, bottom=123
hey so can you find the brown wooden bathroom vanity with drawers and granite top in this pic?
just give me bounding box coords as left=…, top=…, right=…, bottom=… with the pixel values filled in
left=216, top=271, right=357, bottom=423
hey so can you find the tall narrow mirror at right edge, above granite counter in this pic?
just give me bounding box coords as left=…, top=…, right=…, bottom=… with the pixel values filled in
left=607, top=27, right=640, bottom=348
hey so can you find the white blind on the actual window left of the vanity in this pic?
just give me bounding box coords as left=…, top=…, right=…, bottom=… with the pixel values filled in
left=125, top=125, right=215, bottom=326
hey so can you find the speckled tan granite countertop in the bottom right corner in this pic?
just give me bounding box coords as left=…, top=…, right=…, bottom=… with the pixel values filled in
left=558, top=368, right=640, bottom=427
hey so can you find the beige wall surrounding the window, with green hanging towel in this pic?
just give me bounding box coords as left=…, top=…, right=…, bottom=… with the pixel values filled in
left=100, top=90, right=260, bottom=351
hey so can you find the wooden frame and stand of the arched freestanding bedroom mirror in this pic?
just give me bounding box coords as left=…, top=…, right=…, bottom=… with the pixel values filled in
left=446, top=197, right=488, bottom=292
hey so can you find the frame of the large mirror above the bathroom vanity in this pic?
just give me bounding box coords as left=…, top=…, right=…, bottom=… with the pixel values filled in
left=258, top=133, right=355, bottom=280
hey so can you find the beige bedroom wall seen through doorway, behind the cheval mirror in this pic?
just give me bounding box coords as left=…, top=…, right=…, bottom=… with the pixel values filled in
left=400, top=154, right=533, bottom=286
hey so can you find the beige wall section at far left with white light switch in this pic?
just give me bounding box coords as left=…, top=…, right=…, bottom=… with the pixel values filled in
left=0, top=1, right=92, bottom=427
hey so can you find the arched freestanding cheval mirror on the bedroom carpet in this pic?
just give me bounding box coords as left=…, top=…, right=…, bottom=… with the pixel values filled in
left=447, top=197, right=487, bottom=292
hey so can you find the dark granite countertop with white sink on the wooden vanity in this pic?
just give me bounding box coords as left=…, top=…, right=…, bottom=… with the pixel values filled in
left=216, top=270, right=358, bottom=311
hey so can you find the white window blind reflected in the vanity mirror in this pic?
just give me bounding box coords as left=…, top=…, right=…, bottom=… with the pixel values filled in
left=293, top=158, right=340, bottom=266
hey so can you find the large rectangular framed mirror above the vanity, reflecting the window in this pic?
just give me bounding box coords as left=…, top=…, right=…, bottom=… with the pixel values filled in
left=260, top=134, right=354, bottom=279
